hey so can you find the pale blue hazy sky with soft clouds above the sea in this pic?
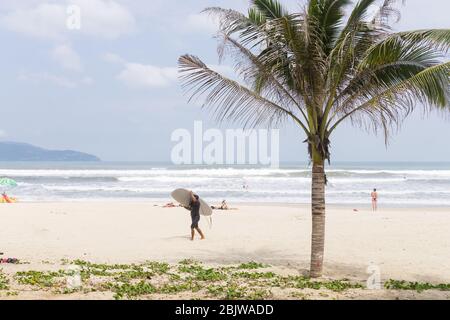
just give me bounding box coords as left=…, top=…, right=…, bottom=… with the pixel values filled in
left=0, top=0, right=450, bottom=162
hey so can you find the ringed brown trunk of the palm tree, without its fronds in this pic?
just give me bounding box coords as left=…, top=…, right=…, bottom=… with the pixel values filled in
left=310, top=160, right=325, bottom=278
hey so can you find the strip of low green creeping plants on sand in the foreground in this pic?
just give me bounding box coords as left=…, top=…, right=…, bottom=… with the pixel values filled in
left=0, top=260, right=450, bottom=300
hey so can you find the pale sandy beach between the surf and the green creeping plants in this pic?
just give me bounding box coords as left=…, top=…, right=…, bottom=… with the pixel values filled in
left=0, top=202, right=450, bottom=298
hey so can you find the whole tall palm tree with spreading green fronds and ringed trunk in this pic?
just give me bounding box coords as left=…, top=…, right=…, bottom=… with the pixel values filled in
left=179, top=0, right=450, bottom=277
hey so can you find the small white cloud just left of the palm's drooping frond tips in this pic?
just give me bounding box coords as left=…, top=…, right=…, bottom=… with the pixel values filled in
left=116, top=63, right=177, bottom=88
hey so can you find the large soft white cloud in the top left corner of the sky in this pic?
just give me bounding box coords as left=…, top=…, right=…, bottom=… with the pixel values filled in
left=0, top=0, right=137, bottom=40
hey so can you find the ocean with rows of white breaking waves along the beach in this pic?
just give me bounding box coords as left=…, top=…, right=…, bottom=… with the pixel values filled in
left=0, top=162, right=450, bottom=207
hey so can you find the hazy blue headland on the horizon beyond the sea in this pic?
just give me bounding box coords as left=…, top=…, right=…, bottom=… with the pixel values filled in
left=0, top=142, right=100, bottom=161
